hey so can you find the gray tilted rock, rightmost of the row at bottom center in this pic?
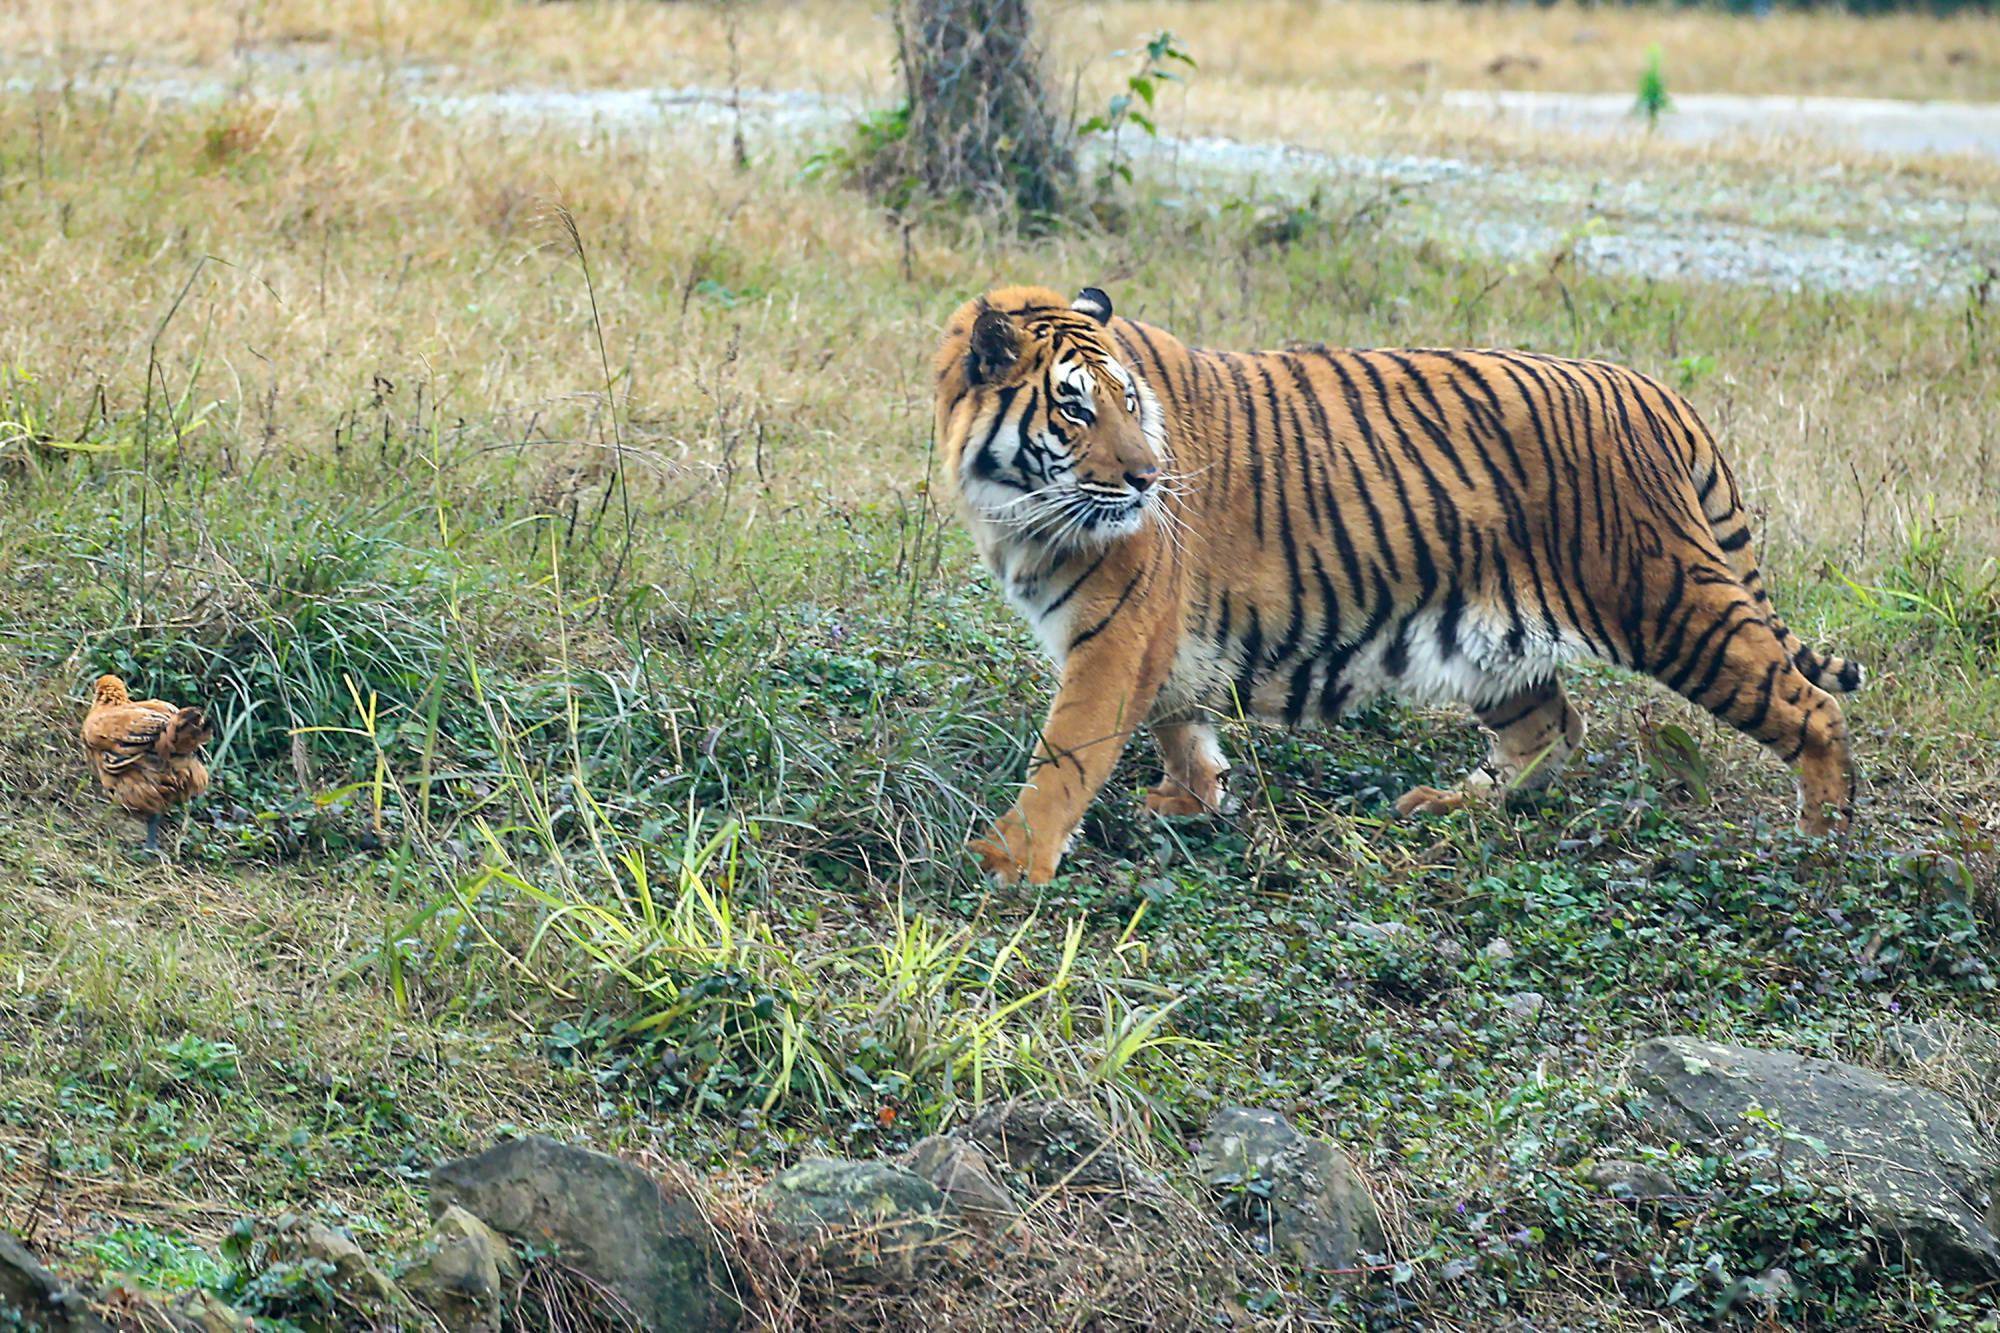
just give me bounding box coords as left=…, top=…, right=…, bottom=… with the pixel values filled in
left=1194, top=1107, right=1388, bottom=1269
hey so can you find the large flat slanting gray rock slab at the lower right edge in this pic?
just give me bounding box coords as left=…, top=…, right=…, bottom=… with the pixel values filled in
left=1632, top=1037, right=2000, bottom=1281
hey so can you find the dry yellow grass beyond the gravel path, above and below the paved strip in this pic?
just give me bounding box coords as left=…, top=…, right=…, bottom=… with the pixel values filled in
left=0, top=0, right=2000, bottom=208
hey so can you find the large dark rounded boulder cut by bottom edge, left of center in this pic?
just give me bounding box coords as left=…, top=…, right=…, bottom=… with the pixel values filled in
left=430, top=1135, right=742, bottom=1333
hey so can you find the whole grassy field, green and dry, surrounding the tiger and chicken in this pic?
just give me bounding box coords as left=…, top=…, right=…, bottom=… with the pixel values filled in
left=0, top=0, right=2000, bottom=1329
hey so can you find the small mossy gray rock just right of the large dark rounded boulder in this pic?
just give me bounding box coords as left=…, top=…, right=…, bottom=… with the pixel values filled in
left=758, top=1157, right=944, bottom=1281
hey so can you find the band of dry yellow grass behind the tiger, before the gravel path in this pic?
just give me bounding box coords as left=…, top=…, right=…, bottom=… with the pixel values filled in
left=0, top=76, right=2000, bottom=554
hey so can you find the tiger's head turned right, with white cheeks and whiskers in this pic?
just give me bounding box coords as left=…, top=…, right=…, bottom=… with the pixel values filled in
left=936, top=286, right=1168, bottom=548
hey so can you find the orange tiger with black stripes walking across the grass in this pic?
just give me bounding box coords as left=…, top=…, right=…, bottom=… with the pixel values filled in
left=934, top=286, right=1862, bottom=885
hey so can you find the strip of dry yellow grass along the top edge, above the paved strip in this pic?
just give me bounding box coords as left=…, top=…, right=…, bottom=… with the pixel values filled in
left=11, top=0, right=2000, bottom=100
